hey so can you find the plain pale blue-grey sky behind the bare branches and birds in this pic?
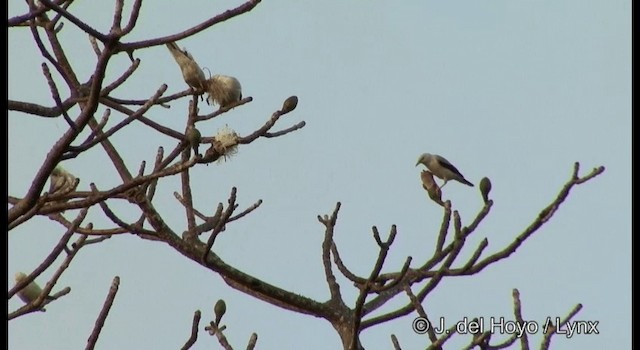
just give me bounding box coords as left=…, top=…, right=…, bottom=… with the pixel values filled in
left=7, top=0, right=632, bottom=349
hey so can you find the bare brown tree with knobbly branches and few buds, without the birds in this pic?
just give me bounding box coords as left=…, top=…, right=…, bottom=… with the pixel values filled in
left=7, top=0, right=604, bottom=349
